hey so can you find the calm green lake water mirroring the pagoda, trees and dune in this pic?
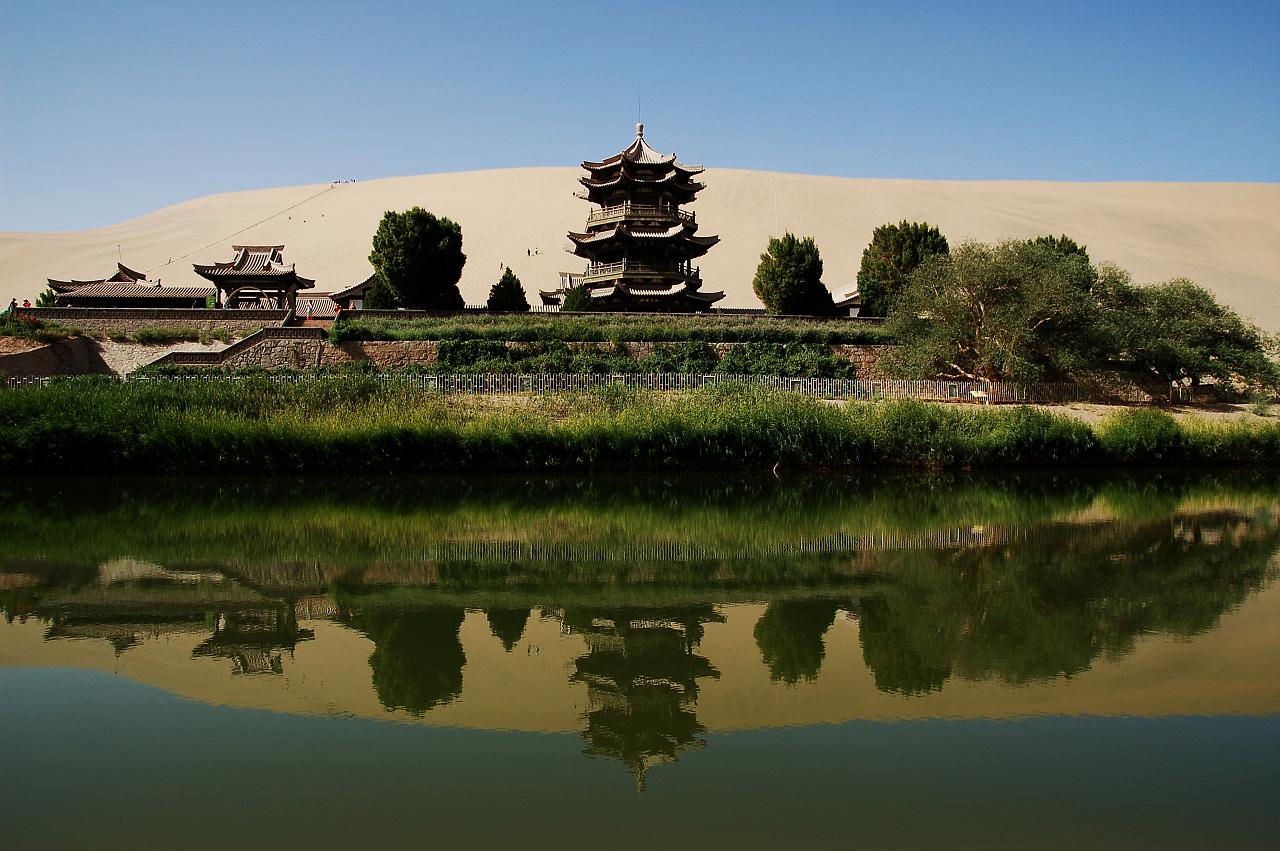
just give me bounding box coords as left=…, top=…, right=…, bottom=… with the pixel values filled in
left=0, top=473, right=1280, bottom=848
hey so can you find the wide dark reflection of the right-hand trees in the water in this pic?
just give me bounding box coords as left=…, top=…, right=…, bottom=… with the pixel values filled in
left=854, top=514, right=1280, bottom=694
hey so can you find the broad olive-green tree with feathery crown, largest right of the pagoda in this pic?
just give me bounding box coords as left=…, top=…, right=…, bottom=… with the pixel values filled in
left=887, top=241, right=1098, bottom=381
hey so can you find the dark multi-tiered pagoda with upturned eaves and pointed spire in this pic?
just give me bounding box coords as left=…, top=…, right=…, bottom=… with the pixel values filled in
left=541, top=124, right=724, bottom=312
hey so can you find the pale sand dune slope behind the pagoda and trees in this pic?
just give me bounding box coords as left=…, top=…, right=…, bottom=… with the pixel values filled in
left=0, top=168, right=1280, bottom=330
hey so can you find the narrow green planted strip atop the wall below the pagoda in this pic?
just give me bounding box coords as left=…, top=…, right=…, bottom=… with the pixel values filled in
left=329, top=314, right=888, bottom=346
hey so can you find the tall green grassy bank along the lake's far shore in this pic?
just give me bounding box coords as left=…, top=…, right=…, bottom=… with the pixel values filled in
left=0, top=376, right=1280, bottom=472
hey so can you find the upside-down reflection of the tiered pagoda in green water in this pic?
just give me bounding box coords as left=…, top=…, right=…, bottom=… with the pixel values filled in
left=563, top=605, right=723, bottom=791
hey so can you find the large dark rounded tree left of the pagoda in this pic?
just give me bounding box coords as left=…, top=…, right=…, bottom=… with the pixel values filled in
left=369, top=207, right=467, bottom=310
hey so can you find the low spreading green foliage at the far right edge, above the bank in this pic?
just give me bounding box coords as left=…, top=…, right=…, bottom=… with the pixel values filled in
left=1098, top=278, right=1280, bottom=388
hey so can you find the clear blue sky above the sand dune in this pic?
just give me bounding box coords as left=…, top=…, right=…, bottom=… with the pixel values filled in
left=0, top=0, right=1280, bottom=230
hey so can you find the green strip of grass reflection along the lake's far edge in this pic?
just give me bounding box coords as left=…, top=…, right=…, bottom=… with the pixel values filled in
left=0, top=476, right=1280, bottom=578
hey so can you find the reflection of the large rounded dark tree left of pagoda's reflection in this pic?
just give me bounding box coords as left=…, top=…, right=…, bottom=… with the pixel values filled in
left=348, top=607, right=467, bottom=715
